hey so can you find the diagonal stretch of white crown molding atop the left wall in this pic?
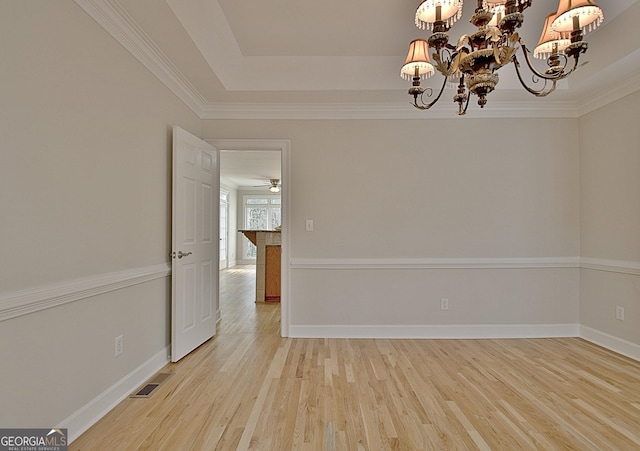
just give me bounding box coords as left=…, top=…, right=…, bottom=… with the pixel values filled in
left=74, top=0, right=207, bottom=118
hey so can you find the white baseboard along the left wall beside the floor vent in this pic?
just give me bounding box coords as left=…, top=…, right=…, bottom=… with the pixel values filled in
left=56, top=346, right=170, bottom=443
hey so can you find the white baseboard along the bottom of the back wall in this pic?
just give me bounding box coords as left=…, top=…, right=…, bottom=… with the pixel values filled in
left=289, top=324, right=580, bottom=339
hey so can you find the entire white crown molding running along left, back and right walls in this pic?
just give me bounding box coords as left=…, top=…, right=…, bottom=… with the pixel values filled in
left=74, top=0, right=640, bottom=120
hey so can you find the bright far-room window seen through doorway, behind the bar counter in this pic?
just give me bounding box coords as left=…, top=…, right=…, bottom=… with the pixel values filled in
left=243, top=194, right=282, bottom=259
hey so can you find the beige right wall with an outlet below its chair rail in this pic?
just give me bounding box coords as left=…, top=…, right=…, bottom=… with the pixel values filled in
left=580, top=91, right=640, bottom=345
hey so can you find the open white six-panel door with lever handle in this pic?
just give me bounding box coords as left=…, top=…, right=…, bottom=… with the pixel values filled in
left=171, top=127, right=220, bottom=362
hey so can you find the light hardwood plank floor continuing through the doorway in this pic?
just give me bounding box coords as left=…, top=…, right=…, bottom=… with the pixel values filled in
left=69, top=267, right=640, bottom=451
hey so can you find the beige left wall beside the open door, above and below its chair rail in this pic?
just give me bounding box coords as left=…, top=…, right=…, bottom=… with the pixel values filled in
left=0, top=1, right=201, bottom=433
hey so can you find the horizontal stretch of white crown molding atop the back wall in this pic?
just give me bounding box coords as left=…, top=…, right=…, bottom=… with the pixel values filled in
left=202, top=100, right=578, bottom=120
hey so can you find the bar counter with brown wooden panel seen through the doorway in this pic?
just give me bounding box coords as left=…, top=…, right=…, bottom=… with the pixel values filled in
left=239, top=230, right=282, bottom=302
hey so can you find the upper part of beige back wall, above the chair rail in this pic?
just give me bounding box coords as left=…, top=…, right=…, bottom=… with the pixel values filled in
left=203, top=119, right=579, bottom=258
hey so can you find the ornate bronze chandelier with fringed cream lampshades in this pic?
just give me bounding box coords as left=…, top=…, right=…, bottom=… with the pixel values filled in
left=400, top=0, right=604, bottom=115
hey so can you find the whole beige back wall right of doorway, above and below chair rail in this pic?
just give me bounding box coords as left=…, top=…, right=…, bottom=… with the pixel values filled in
left=203, top=118, right=580, bottom=335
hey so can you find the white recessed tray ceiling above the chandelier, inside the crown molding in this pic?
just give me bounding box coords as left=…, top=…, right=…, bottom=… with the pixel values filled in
left=107, top=0, right=636, bottom=105
